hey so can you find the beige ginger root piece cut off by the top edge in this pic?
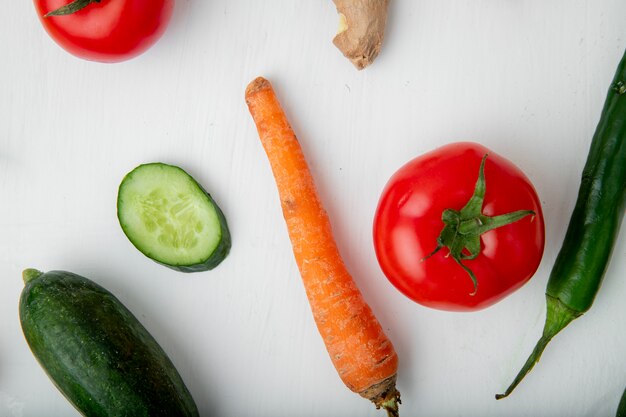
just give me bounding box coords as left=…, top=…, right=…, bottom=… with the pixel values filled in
left=333, top=0, right=389, bottom=70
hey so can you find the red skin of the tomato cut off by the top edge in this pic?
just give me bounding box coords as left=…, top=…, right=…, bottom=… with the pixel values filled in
left=34, top=0, right=174, bottom=62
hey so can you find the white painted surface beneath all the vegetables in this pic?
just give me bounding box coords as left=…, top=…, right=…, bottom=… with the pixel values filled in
left=0, top=0, right=626, bottom=417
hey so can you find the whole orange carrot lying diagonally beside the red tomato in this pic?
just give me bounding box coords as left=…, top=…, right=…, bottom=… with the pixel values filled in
left=246, top=78, right=400, bottom=416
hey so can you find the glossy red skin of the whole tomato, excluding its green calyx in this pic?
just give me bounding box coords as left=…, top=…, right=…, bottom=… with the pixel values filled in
left=374, top=143, right=545, bottom=311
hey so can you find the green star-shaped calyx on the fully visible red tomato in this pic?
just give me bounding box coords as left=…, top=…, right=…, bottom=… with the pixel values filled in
left=422, top=154, right=535, bottom=295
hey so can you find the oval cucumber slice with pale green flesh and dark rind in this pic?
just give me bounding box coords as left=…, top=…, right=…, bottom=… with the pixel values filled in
left=117, top=162, right=231, bottom=272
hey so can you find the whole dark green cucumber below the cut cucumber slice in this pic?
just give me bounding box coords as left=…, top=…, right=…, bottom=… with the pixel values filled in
left=19, top=269, right=198, bottom=417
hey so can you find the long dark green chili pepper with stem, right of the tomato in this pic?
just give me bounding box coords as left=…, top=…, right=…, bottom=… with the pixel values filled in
left=496, top=47, right=626, bottom=399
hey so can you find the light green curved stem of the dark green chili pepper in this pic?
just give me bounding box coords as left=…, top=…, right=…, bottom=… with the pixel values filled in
left=496, top=294, right=582, bottom=400
